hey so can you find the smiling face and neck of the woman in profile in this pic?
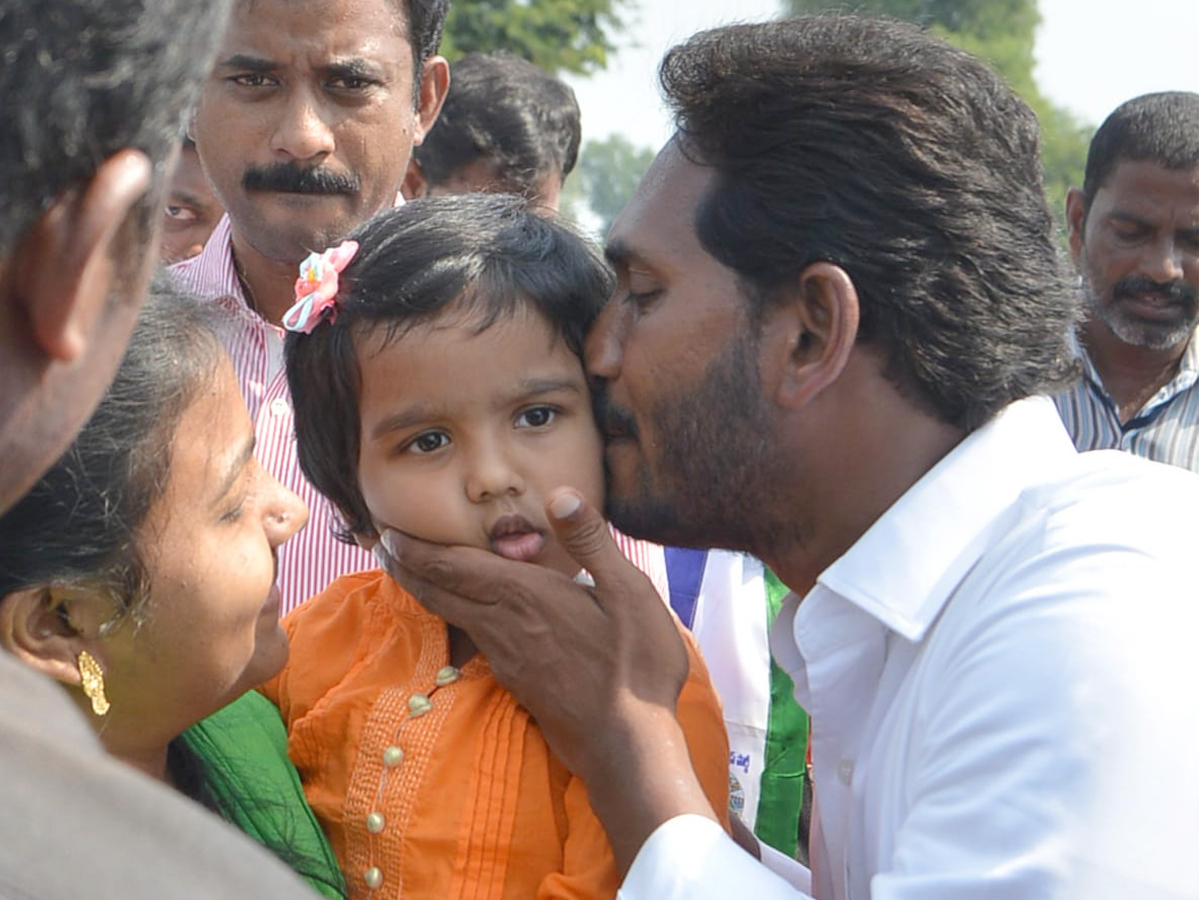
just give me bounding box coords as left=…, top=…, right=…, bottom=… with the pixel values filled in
left=96, top=355, right=308, bottom=762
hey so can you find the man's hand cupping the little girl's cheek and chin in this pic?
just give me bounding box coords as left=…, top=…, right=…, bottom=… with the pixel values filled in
left=377, top=488, right=713, bottom=871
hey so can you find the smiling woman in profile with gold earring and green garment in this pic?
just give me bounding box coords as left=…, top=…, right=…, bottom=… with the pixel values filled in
left=0, top=284, right=346, bottom=898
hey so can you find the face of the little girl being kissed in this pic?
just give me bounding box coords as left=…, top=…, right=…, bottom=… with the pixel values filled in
left=356, top=306, right=604, bottom=576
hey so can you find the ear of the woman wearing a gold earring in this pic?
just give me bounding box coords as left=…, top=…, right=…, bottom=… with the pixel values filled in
left=0, top=587, right=100, bottom=684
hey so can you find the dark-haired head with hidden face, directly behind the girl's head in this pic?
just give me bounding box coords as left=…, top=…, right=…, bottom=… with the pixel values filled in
left=404, top=53, right=580, bottom=212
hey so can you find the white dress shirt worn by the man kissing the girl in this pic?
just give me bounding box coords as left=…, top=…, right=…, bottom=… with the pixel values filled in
left=620, top=398, right=1200, bottom=900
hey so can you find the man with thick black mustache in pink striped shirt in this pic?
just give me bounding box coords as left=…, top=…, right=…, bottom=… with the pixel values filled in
left=173, top=0, right=449, bottom=612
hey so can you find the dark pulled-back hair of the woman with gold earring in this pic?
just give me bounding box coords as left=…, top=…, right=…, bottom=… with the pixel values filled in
left=0, top=274, right=222, bottom=624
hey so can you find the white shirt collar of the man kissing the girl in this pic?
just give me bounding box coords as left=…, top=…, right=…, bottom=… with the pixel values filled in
left=817, top=397, right=1076, bottom=641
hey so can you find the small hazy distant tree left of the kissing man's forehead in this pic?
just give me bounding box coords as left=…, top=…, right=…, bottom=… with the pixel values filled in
left=563, top=134, right=654, bottom=239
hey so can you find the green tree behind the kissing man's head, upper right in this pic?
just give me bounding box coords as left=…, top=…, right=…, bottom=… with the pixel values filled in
left=784, top=0, right=1092, bottom=222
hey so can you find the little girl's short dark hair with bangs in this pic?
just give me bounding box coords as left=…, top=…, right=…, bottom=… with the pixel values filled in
left=284, top=193, right=612, bottom=540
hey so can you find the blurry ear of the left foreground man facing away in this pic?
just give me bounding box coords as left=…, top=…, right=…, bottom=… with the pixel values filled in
left=13, top=150, right=151, bottom=362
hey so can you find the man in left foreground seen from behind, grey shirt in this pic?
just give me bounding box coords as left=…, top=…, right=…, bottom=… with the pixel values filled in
left=0, top=0, right=307, bottom=900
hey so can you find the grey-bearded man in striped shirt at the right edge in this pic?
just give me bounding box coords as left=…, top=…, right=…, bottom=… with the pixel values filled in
left=1055, top=91, right=1200, bottom=472
